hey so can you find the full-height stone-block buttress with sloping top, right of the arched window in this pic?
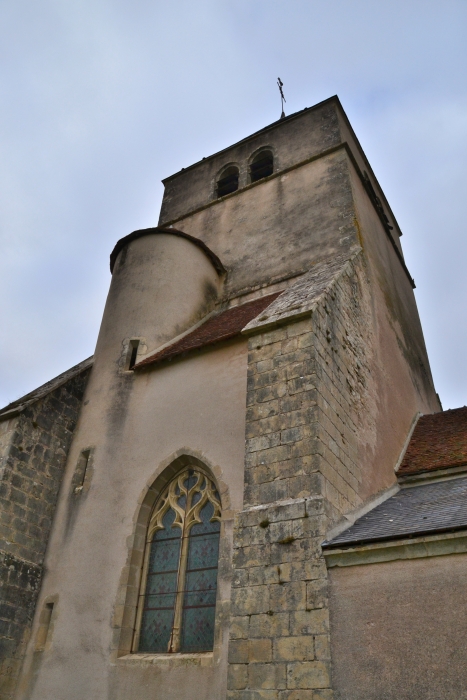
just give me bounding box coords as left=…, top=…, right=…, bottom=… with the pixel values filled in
left=228, top=256, right=371, bottom=700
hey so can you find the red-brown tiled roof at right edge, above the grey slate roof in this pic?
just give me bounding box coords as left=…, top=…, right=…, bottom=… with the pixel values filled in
left=397, top=406, right=467, bottom=476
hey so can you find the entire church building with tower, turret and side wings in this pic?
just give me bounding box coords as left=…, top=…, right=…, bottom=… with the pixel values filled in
left=0, top=97, right=467, bottom=700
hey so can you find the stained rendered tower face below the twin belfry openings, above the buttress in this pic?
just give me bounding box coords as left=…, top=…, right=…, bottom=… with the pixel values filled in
left=164, top=150, right=358, bottom=297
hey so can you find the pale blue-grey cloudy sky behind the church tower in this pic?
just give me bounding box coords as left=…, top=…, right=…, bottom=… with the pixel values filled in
left=0, top=0, right=467, bottom=408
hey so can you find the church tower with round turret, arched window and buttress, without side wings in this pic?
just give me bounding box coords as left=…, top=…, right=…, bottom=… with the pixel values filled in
left=5, top=97, right=440, bottom=700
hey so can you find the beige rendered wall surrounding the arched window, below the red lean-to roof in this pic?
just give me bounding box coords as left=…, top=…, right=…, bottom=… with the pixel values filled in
left=16, top=340, right=247, bottom=700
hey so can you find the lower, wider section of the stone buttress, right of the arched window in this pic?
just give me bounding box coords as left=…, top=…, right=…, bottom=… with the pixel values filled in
left=228, top=496, right=331, bottom=700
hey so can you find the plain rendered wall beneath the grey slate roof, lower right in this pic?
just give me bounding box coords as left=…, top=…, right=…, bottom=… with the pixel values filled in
left=329, top=555, right=467, bottom=700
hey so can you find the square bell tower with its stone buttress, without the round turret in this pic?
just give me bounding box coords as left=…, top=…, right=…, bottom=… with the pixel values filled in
left=155, top=98, right=440, bottom=700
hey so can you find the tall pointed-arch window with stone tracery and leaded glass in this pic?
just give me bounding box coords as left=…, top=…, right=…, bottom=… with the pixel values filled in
left=137, top=467, right=221, bottom=654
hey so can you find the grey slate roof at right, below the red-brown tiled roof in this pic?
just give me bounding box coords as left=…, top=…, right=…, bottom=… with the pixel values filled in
left=322, top=476, right=467, bottom=549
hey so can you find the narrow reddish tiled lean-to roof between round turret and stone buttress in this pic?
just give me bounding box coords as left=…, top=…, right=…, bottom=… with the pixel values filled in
left=135, top=292, right=280, bottom=369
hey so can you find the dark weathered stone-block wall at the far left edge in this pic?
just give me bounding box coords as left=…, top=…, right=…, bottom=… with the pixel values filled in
left=0, top=368, right=89, bottom=700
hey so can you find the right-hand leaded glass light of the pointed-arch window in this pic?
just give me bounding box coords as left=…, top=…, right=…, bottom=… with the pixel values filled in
left=181, top=501, right=220, bottom=652
